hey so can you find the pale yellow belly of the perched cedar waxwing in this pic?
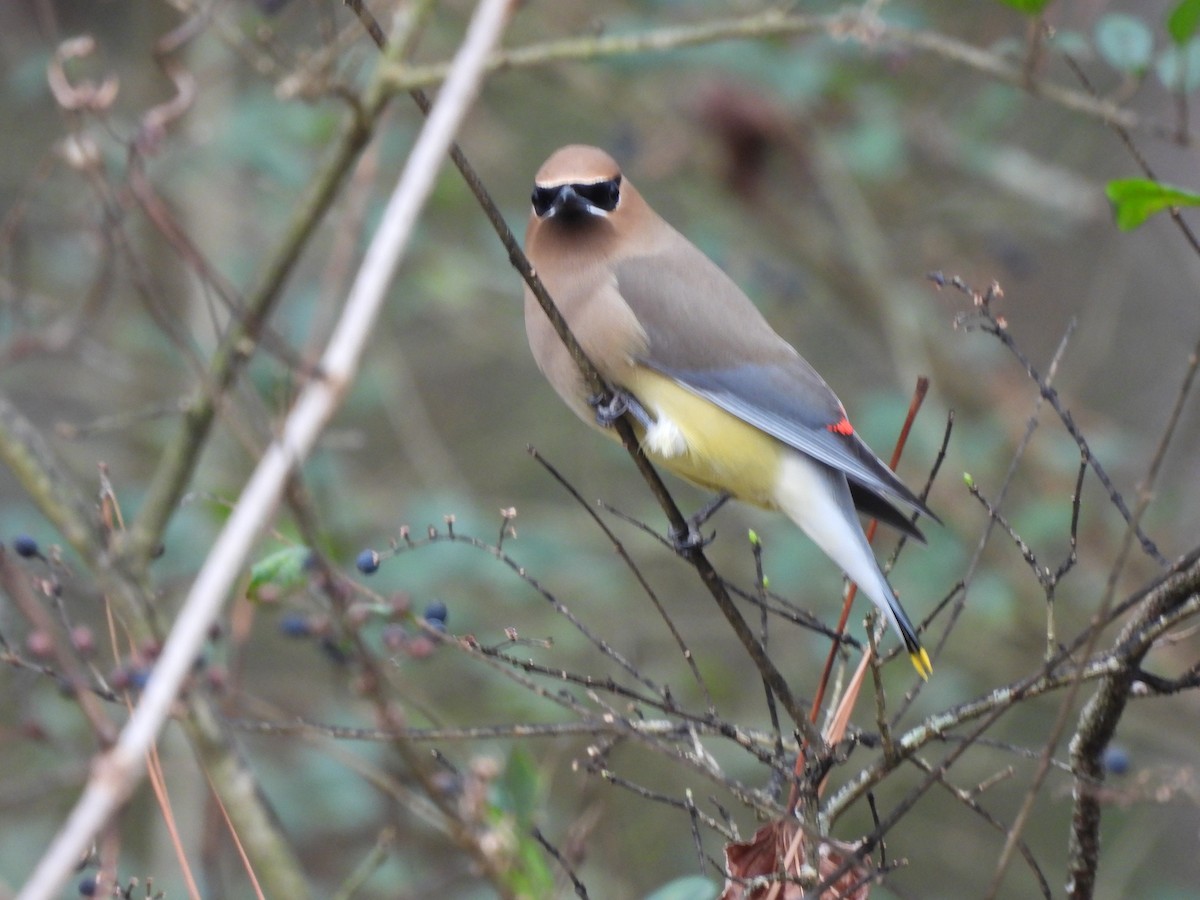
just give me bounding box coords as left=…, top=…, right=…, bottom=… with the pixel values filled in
left=623, top=367, right=787, bottom=509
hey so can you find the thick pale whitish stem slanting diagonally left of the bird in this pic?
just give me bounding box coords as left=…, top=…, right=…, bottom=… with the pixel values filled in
left=18, top=0, right=512, bottom=900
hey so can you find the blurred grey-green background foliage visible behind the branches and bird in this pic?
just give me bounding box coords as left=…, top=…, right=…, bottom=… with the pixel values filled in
left=0, top=0, right=1200, bottom=899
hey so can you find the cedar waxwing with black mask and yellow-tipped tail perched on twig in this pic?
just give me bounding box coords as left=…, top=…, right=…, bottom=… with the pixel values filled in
left=524, top=144, right=940, bottom=679
